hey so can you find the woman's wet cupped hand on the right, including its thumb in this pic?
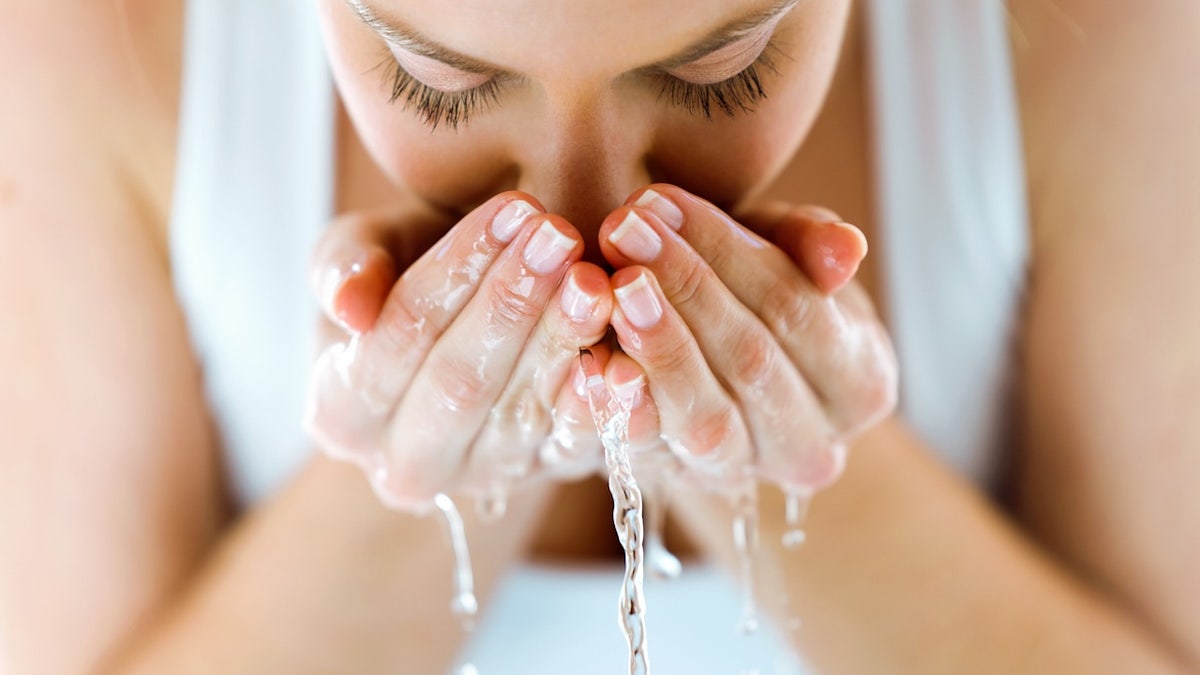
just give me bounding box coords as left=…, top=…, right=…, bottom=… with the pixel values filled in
left=600, top=185, right=898, bottom=490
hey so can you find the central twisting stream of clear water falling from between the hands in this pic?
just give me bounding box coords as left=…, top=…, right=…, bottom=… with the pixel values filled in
left=580, top=351, right=650, bottom=675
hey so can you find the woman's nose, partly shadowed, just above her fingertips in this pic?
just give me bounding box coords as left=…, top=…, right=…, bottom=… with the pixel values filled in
left=517, top=92, right=650, bottom=262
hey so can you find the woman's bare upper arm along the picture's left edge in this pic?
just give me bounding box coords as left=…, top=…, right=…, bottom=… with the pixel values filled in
left=0, top=0, right=221, bottom=673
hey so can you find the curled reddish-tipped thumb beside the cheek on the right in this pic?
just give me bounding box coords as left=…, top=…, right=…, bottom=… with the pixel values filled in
left=738, top=203, right=868, bottom=295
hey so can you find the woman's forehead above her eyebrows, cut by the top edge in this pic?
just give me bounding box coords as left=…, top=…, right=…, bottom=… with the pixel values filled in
left=379, top=0, right=779, bottom=77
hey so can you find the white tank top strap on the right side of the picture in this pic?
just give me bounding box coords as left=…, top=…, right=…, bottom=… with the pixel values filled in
left=866, top=0, right=1028, bottom=483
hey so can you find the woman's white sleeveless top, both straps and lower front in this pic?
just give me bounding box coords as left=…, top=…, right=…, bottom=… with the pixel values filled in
left=170, top=0, right=1028, bottom=675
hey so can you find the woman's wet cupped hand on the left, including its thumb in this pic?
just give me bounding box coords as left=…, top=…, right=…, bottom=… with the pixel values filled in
left=306, top=192, right=612, bottom=512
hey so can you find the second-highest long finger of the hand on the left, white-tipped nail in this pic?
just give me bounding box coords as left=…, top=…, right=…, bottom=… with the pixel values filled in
left=376, top=215, right=583, bottom=500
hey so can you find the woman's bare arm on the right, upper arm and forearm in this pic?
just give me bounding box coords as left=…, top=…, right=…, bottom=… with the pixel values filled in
left=678, top=2, right=1200, bottom=673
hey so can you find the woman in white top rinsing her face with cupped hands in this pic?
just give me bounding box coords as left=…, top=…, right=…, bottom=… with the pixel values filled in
left=0, top=0, right=1200, bottom=673
